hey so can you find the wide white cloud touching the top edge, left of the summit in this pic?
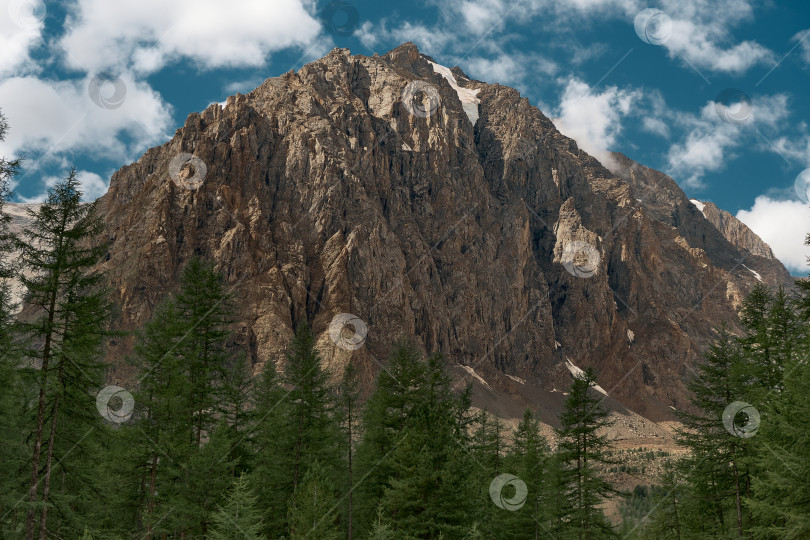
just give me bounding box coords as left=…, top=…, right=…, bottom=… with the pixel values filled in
left=60, top=0, right=321, bottom=73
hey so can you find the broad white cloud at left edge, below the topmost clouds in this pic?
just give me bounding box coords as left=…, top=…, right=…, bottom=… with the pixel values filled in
left=0, top=76, right=172, bottom=162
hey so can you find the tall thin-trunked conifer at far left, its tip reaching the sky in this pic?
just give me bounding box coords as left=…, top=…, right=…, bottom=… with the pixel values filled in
left=18, top=170, right=109, bottom=539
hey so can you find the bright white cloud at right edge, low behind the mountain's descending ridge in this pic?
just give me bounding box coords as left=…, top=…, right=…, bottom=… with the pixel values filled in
left=737, top=195, right=810, bottom=274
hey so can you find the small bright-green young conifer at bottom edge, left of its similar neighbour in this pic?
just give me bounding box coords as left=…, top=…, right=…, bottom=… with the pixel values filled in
left=209, top=473, right=264, bottom=540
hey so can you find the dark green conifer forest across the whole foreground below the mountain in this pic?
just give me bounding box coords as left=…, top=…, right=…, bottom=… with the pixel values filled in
left=0, top=119, right=810, bottom=539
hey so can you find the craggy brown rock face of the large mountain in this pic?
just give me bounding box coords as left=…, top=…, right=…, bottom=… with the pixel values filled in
left=36, top=44, right=789, bottom=419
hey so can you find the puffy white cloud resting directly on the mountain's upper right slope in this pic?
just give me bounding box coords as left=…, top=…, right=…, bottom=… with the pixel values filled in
left=554, top=77, right=643, bottom=165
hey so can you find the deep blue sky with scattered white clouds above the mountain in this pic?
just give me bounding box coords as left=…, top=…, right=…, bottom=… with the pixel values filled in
left=0, top=0, right=810, bottom=275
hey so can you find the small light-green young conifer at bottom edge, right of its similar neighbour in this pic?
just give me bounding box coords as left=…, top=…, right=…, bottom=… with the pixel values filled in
left=287, top=461, right=344, bottom=540
